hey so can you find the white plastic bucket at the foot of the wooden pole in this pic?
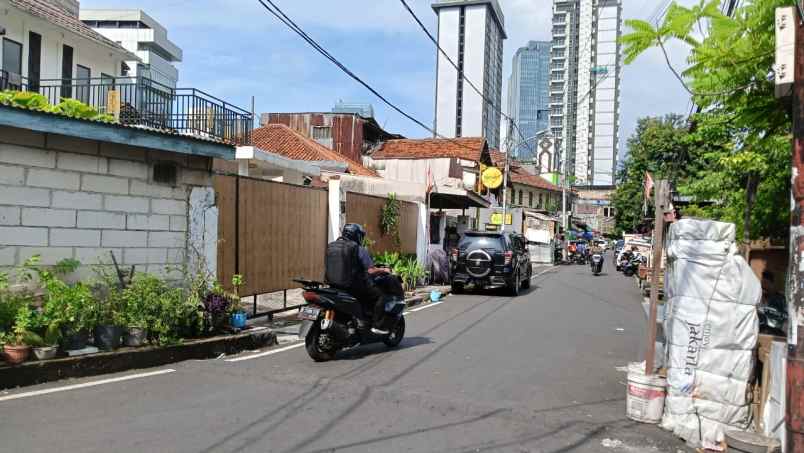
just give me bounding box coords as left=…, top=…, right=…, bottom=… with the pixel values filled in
left=625, top=363, right=667, bottom=424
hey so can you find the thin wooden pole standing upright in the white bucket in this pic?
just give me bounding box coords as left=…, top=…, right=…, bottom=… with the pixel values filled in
left=645, top=179, right=670, bottom=375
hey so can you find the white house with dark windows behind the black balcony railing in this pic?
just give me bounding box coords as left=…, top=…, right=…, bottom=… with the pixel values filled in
left=0, top=0, right=131, bottom=91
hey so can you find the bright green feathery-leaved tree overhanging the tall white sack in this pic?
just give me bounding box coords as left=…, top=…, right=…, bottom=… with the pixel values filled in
left=622, top=0, right=795, bottom=239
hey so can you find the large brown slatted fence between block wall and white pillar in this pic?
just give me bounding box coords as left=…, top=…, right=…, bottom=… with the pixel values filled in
left=213, top=175, right=328, bottom=296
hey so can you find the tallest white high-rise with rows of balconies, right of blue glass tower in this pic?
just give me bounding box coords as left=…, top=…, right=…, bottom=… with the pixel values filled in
left=550, top=0, right=622, bottom=187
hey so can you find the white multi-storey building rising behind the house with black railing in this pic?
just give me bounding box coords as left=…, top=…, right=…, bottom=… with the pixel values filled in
left=80, top=9, right=182, bottom=88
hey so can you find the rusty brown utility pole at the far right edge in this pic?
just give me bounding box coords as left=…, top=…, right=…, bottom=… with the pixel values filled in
left=785, top=2, right=804, bottom=453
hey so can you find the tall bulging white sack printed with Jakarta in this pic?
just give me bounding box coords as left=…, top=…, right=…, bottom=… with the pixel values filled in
left=661, top=219, right=762, bottom=450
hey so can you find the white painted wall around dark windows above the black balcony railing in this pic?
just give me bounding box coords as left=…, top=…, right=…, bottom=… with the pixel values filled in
left=0, top=0, right=124, bottom=79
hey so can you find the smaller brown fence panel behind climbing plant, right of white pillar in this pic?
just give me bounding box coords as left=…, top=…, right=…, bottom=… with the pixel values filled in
left=346, top=192, right=419, bottom=253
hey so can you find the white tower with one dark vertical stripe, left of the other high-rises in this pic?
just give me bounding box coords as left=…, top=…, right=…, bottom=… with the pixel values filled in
left=433, top=0, right=506, bottom=148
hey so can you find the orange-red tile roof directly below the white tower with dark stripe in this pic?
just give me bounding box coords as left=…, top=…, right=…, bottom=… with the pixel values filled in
left=371, top=137, right=486, bottom=162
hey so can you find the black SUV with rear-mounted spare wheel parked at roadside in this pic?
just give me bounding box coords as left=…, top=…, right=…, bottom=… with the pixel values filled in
left=450, top=231, right=533, bottom=296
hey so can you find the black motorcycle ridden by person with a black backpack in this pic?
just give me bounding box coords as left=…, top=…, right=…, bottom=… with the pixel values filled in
left=294, top=274, right=405, bottom=362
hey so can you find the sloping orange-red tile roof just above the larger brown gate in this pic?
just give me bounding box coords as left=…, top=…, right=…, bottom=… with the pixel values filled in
left=252, top=124, right=379, bottom=177
